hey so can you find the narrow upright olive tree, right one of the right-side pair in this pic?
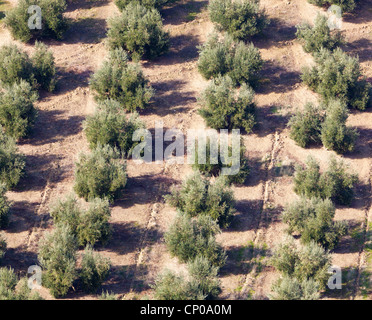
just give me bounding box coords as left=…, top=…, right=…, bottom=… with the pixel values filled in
left=321, top=100, right=358, bottom=153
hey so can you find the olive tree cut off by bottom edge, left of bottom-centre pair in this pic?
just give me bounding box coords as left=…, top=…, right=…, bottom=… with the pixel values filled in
left=152, top=271, right=204, bottom=300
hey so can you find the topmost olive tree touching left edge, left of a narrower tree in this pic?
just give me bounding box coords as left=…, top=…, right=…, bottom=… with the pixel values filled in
left=0, top=44, right=35, bottom=88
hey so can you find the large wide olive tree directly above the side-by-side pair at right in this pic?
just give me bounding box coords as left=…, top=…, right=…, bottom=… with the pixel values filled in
left=301, top=48, right=371, bottom=110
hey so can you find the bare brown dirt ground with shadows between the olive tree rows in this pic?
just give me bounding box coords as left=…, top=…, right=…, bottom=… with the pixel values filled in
left=0, top=0, right=372, bottom=299
